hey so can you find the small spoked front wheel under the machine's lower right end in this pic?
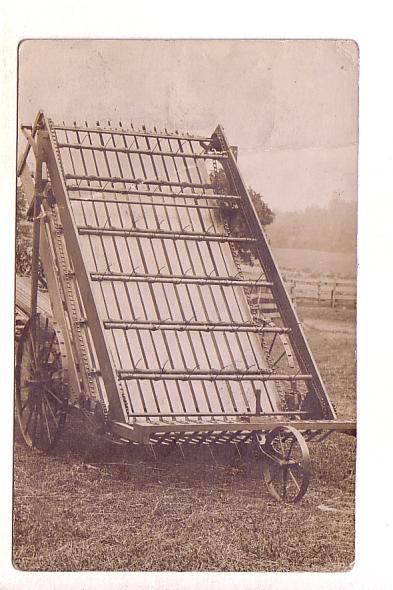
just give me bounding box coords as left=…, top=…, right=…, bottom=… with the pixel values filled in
left=262, top=426, right=311, bottom=503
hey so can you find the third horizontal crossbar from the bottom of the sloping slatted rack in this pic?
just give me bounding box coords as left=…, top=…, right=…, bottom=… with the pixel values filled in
left=104, top=319, right=289, bottom=334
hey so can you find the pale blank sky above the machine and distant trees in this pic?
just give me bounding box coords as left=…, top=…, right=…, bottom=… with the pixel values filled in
left=18, top=40, right=358, bottom=210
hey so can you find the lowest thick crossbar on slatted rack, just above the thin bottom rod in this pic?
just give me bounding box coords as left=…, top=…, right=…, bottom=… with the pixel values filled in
left=117, top=369, right=312, bottom=381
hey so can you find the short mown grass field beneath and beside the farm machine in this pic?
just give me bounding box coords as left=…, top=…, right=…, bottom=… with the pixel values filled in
left=13, top=307, right=355, bottom=571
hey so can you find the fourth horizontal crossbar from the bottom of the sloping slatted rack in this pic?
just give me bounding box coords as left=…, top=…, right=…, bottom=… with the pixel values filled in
left=90, top=272, right=272, bottom=288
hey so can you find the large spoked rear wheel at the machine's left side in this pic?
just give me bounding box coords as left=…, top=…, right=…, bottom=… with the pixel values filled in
left=15, top=314, right=67, bottom=451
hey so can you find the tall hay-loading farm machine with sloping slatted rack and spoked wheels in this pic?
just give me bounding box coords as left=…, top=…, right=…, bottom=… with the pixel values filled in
left=15, top=112, right=356, bottom=502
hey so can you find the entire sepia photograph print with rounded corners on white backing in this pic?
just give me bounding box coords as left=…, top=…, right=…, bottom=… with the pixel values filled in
left=12, top=39, right=359, bottom=572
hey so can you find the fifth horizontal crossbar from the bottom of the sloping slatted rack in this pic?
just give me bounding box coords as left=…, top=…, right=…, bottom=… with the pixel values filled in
left=78, top=226, right=256, bottom=245
